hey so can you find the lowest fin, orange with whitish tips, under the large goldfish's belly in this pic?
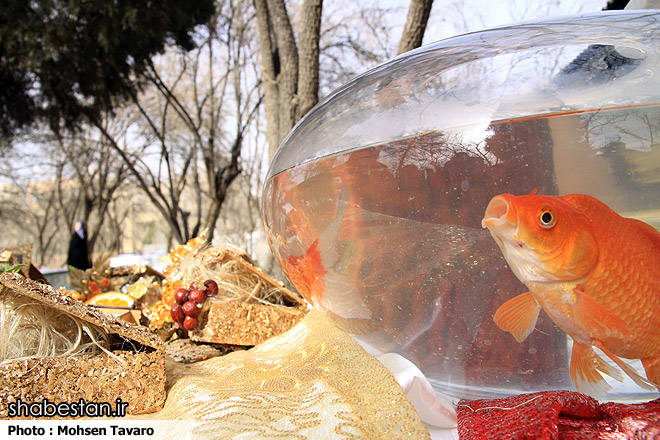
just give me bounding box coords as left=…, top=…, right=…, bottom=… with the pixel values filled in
left=570, top=341, right=612, bottom=398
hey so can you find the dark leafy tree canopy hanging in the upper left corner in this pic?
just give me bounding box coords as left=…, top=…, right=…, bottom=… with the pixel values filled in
left=0, top=0, right=214, bottom=138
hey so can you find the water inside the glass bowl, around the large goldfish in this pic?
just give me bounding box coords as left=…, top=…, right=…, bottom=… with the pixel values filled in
left=264, top=105, right=660, bottom=401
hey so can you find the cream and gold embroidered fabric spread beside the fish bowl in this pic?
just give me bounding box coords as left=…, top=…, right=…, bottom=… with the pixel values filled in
left=140, top=311, right=429, bottom=439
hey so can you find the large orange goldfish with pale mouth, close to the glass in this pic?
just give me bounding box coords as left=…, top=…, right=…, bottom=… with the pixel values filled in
left=481, top=191, right=660, bottom=397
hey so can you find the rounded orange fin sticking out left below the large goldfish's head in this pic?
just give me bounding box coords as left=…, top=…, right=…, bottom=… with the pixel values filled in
left=493, top=292, right=541, bottom=342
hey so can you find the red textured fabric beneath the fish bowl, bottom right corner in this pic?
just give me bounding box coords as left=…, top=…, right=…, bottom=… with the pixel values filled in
left=457, top=391, right=660, bottom=440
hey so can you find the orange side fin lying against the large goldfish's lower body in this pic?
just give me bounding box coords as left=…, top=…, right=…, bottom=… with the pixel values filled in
left=573, top=287, right=632, bottom=340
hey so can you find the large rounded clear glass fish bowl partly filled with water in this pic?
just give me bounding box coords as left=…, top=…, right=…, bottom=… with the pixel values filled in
left=263, top=11, right=660, bottom=401
